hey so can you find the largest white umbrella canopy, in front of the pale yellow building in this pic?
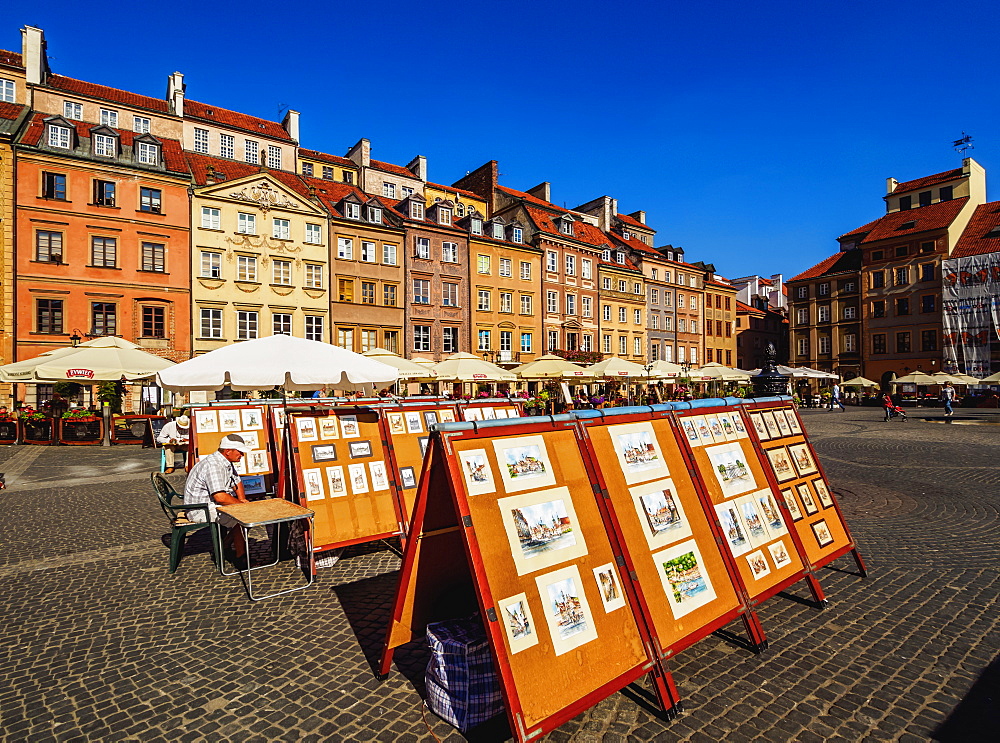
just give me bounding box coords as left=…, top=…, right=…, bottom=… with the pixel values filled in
left=157, top=335, right=399, bottom=392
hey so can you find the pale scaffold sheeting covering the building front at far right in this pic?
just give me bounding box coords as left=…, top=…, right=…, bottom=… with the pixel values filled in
left=941, top=253, right=1000, bottom=378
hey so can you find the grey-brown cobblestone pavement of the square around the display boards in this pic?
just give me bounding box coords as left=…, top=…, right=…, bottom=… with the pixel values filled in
left=0, top=408, right=1000, bottom=743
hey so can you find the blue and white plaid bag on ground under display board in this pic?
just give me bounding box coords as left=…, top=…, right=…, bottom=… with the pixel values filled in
left=424, top=614, right=503, bottom=733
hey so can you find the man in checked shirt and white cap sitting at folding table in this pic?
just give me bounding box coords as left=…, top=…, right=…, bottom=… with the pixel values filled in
left=184, top=433, right=250, bottom=557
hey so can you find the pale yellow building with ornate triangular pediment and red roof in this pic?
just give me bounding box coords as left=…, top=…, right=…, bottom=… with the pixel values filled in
left=187, top=153, right=330, bottom=354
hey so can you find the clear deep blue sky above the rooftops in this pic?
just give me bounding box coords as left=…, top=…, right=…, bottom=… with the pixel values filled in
left=7, top=0, right=1000, bottom=277
